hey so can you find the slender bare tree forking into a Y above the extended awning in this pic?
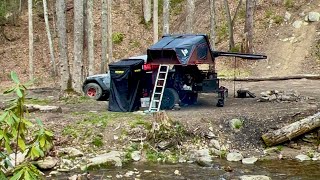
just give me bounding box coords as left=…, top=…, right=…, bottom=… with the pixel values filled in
left=224, top=0, right=242, bottom=50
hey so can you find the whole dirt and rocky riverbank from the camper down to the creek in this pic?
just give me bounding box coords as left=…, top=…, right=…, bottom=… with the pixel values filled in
left=0, top=80, right=320, bottom=178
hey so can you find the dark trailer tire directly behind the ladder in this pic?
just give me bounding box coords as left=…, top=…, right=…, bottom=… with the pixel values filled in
left=160, top=88, right=179, bottom=109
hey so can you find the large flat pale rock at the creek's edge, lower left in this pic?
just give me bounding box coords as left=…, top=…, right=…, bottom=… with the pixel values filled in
left=86, top=151, right=122, bottom=168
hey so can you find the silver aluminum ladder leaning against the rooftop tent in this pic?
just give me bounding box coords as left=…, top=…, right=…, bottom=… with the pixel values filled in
left=149, top=64, right=170, bottom=112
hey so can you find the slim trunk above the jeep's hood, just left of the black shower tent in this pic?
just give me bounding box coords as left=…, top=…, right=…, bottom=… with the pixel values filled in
left=100, top=0, right=108, bottom=73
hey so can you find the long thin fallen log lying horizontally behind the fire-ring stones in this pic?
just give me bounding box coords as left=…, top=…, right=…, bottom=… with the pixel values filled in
left=219, top=74, right=320, bottom=82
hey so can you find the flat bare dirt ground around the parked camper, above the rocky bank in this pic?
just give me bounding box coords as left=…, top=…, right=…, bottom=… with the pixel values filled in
left=0, top=79, right=320, bottom=158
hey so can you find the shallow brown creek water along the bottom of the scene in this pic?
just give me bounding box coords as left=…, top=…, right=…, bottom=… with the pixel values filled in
left=73, top=160, right=320, bottom=180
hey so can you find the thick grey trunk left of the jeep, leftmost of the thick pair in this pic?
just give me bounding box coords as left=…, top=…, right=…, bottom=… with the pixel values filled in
left=56, top=0, right=71, bottom=91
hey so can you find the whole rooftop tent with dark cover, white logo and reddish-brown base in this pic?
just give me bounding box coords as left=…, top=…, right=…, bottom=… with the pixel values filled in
left=147, top=35, right=214, bottom=65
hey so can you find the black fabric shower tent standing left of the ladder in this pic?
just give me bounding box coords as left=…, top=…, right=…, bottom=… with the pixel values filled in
left=108, top=59, right=144, bottom=112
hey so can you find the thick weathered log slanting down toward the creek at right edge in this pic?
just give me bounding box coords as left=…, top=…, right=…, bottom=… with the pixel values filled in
left=262, top=112, right=320, bottom=146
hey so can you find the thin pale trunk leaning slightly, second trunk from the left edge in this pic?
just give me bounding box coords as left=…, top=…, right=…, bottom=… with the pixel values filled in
left=42, top=0, right=57, bottom=76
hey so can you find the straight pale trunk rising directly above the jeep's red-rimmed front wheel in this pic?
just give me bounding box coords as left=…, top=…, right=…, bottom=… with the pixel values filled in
left=87, top=0, right=95, bottom=76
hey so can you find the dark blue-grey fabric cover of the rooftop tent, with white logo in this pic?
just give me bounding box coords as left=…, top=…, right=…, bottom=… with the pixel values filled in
left=147, top=35, right=211, bottom=65
